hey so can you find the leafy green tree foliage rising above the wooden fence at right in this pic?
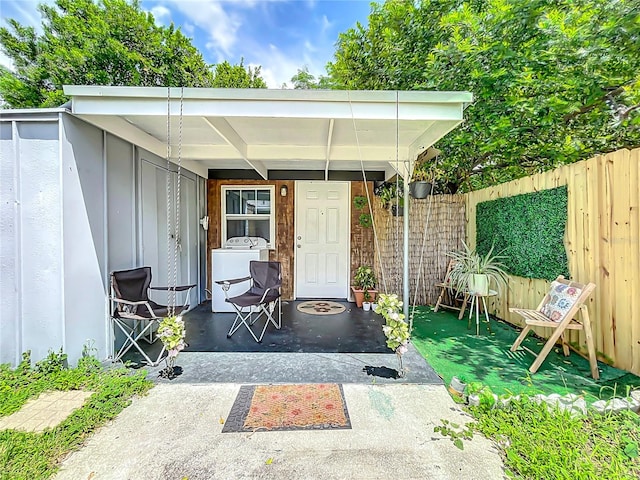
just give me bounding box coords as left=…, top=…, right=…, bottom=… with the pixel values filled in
left=327, top=0, right=640, bottom=191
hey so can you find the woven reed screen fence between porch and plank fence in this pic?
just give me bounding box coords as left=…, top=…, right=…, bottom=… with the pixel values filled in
left=373, top=195, right=465, bottom=305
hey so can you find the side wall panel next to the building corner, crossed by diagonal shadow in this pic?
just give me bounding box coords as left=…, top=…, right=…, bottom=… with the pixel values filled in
left=61, top=115, right=109, bottom=363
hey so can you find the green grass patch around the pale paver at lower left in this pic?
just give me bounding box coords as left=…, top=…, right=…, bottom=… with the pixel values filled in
left=0, top=346, right=152, bottom=480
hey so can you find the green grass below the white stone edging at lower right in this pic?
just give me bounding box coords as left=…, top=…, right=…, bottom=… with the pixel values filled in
left=470, top=401, right=640, bottom=480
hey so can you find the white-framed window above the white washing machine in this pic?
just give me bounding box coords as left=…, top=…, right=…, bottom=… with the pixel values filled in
left=221, top=185, right=276, bottom=248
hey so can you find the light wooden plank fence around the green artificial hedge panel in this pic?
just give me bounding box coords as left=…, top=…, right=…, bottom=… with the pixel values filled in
left=465, top=149, right=640, bottom=375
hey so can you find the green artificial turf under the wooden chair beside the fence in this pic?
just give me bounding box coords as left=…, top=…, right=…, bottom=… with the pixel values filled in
left=412, top=307, right=640, bottom=401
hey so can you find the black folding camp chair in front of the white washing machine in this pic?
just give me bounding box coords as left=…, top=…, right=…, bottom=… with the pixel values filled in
left=216, top=260, right=282, bottom=343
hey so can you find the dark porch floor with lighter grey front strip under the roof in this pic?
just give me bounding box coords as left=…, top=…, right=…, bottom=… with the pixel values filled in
left=125, top=302, right=442, bottom=384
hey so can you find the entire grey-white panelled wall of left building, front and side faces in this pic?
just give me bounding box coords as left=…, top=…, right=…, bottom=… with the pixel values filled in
left=0, top=112, right=206, bottom=365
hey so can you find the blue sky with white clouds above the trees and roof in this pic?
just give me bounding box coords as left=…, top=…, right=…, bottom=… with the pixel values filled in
left=0, top=0, right=370, bottom=88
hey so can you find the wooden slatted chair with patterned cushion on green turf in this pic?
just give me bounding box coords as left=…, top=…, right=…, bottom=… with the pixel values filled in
left=509, top=275, right=600, bottom=380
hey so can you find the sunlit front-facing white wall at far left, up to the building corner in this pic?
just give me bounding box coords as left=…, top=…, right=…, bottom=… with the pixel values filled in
left=0, top=120, right=66, bottom=363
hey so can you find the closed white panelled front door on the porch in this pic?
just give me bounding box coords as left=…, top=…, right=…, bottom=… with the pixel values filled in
left=295, top=181, right=350, bottom=298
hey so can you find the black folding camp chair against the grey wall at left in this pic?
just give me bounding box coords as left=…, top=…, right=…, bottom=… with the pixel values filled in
left=110, top=267, right=195, bottom=366
